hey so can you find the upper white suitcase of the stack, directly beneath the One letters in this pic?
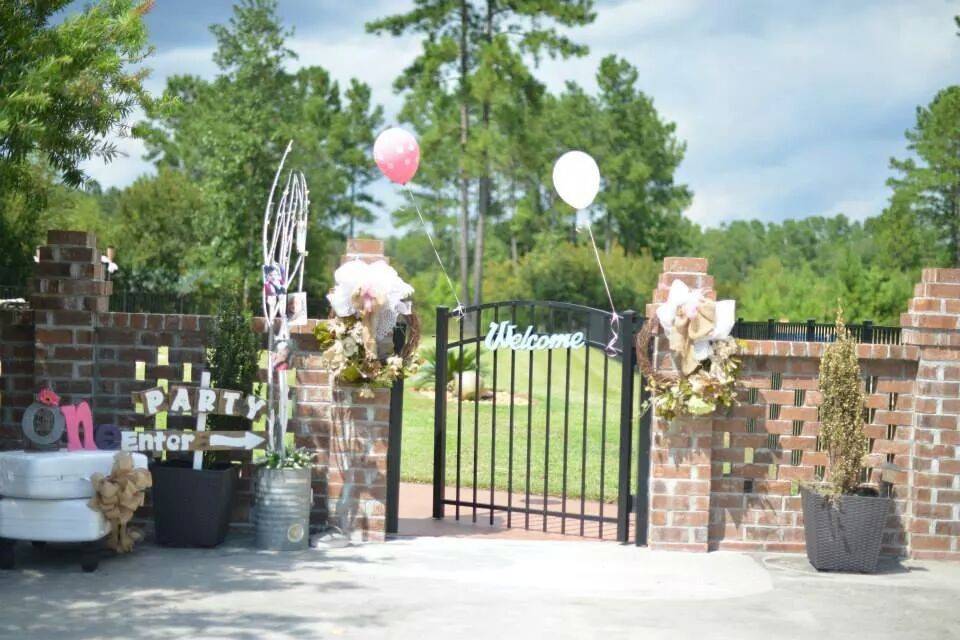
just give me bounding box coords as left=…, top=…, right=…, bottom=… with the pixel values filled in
left=0, top=449, right=147, bottom=500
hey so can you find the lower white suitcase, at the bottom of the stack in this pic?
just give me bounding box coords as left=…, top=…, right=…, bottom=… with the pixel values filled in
left=0, top=498, right=110, bottom=542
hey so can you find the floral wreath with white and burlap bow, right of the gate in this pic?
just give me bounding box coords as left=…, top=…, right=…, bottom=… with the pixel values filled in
left=635, top=280, right=740, bottom=421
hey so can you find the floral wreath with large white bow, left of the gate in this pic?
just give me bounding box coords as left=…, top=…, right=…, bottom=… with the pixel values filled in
left=313, top=260, right=420, bottom=397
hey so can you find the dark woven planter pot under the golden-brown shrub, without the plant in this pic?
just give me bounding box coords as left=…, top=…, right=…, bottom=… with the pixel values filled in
left=800, top=487, right=890, bottom=573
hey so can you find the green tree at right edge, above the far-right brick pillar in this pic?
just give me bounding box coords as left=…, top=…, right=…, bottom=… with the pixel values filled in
left=888, top=85, right=960, bottom=267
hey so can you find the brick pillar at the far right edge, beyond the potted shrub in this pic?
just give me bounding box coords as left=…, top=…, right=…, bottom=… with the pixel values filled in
left=900, top=269, right=960, bottom=560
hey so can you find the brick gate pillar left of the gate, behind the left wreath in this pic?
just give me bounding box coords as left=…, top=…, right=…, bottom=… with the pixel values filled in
left=294, top=239, right=390, bottom=540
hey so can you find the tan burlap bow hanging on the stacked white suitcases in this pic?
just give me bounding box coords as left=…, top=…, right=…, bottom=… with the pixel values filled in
left=89, top=451, right=153, bottom=553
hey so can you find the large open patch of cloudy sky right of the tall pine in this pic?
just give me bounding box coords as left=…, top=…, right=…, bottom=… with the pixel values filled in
left=543, top=0, right=960, bottom=224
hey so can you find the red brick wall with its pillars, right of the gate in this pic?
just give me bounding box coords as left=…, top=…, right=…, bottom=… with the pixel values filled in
left=647, top=258, right=960, bottom=559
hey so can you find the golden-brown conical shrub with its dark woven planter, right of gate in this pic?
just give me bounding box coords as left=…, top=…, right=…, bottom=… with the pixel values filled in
left=801, top=310, right=890, bottom=573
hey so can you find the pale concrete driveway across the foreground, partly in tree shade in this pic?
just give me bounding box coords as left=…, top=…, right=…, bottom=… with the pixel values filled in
left=0, top=536, right=960, bottom=640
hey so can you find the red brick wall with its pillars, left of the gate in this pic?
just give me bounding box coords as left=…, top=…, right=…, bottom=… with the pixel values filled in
left=0, top=231, right=389, bottom=539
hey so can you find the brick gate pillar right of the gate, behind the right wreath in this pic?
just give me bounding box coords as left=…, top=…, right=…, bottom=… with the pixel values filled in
left=646, top=258, right=716, bottom=552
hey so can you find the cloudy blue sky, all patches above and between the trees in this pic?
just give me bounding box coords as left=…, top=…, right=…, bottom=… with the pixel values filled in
left=80, top=0, right=960, bottom=232
